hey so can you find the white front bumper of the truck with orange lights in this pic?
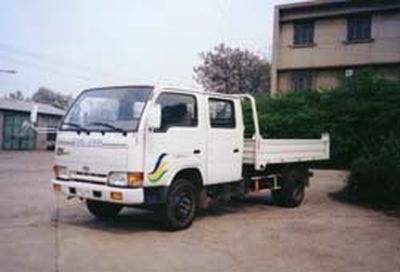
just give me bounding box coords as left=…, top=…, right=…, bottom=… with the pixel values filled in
left=51, top=179, right=144, bottom=205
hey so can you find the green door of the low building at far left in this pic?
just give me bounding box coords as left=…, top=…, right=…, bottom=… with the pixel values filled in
left=3, top=112, right=36, bottom=150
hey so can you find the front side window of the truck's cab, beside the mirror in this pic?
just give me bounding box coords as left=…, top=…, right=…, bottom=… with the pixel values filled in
left=157, top=93, right=197, bottom=130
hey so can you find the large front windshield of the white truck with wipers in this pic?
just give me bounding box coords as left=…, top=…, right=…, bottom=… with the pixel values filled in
left=60, top=87, right=153, bottom=132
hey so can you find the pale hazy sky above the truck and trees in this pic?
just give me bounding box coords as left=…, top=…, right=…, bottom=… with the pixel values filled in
left=0, top=0, right=298, bottom=97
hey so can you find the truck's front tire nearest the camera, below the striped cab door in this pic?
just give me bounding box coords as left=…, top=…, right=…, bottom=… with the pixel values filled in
left=161, top=178, right=198, bottom=231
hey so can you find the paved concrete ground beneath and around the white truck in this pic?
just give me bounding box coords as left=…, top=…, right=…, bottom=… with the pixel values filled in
left=0, top=152, right=400, bottom=272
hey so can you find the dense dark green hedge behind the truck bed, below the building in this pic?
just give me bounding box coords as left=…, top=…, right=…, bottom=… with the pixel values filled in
left=244, top=71, right=400, bottom=205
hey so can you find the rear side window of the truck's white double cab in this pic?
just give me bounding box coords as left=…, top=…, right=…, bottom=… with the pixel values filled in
left=208, top=98, right=236, bottom=128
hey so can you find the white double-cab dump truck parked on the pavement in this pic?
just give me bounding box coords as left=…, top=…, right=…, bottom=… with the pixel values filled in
left=51, top=86, right=329, bottom=230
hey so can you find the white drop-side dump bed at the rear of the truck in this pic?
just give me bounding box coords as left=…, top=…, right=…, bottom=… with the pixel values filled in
left=243, top=134, right=329, bottom=170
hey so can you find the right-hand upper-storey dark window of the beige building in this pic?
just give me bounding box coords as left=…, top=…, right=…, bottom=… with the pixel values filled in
left=347, top=16, right=371, bottom=41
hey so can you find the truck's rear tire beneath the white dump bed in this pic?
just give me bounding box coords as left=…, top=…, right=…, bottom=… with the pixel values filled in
left=272, top=170, right=305, bottom=207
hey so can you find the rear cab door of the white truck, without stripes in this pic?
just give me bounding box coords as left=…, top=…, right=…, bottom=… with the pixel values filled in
left=207, top=97, right=243, bottom=184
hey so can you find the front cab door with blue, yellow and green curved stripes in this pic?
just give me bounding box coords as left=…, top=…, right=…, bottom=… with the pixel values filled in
left=145, top=91, right=206, bottom=186
